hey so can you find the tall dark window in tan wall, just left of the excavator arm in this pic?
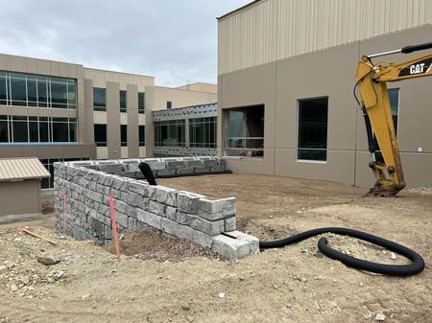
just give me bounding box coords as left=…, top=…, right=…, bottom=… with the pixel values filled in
left=297, top=98, right=328, bottom=161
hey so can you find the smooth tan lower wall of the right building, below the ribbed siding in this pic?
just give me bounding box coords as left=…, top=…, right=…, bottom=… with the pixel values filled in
left=218, top=26, right=432, bottom=187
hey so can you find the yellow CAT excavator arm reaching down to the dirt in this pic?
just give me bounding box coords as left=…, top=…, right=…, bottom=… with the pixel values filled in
left=354, top=43, right=432, bottom=196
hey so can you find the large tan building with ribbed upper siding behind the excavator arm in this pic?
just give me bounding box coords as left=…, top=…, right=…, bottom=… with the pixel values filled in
left=218, top=0, right=432, bottom=187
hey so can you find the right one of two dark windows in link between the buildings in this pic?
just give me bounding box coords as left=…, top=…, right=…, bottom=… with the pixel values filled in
left=189, top=117, right=217, bottom=148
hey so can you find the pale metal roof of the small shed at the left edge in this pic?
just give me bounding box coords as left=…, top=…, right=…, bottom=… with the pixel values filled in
left=0, top=157, right=51, bottom=182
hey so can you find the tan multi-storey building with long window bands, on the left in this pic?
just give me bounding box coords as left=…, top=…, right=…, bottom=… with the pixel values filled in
left=0, top=55, right=217, bottom=188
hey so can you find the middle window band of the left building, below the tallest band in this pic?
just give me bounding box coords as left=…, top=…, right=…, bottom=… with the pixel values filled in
left=0, top=116, right=77, bottom=143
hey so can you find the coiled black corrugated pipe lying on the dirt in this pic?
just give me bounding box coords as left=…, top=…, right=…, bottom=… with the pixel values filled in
left=259, top=227, right=425, bottom=276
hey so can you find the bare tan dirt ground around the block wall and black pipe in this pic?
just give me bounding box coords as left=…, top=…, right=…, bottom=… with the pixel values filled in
left=0, top=174, right=432, bottom=323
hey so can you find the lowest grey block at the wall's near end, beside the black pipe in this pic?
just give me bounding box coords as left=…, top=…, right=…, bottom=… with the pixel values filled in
left=212, top=231, right=259, bottom=260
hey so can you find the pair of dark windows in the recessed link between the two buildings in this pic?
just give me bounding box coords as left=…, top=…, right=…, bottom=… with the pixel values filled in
left=154, top=117, right=217, bottom=148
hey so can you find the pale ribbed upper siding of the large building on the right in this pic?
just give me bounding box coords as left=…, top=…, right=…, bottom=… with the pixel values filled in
left=218, top=0, right=432, bottom=74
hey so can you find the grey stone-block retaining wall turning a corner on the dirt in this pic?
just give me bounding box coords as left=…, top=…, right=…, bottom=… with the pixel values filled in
left=54, top=157, right=259, bottom=259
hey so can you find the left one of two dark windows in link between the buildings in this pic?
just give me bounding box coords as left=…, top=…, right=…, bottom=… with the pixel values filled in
left=154, top=120, right=185, bottom=147
